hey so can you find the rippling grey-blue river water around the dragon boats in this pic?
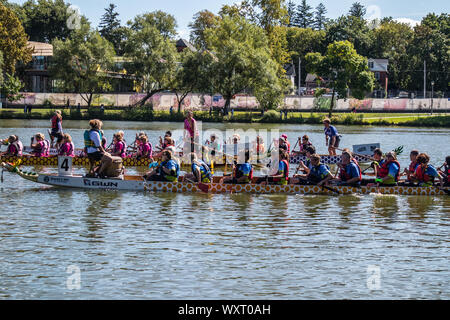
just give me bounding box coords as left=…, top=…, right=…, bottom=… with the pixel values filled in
left=0, top=120, right=450, bottom=299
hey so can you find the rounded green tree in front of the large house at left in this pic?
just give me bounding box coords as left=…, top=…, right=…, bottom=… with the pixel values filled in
left=50, top=24, right=115, bottom=107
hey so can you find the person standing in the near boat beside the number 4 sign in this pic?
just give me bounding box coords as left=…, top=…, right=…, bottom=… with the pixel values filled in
left=84, top=119, right=106, bottom=175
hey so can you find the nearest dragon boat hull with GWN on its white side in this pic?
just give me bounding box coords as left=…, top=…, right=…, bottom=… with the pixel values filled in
left=1, top=163, right=450, bottom=196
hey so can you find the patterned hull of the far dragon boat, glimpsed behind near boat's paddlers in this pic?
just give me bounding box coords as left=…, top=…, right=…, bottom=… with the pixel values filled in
left=0, top=155, right=367, bottom=167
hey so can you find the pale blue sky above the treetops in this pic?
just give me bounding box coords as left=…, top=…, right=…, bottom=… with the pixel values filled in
left=10, top=0, right=450, bottom=38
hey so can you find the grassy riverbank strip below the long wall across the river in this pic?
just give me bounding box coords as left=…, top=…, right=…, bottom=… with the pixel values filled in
left=0, top=108, right=450, bottom=128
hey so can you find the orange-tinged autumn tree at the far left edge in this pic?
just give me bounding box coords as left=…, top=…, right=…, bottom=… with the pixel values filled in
left=0, top=4, right=32, bottom=74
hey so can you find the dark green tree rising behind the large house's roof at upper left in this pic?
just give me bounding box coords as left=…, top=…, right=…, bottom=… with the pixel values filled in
left=22, top=0, right=76, bottom=43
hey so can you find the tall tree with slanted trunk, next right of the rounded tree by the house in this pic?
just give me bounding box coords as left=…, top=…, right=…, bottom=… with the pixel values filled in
left=125, top=11, right=177, bottom=106
